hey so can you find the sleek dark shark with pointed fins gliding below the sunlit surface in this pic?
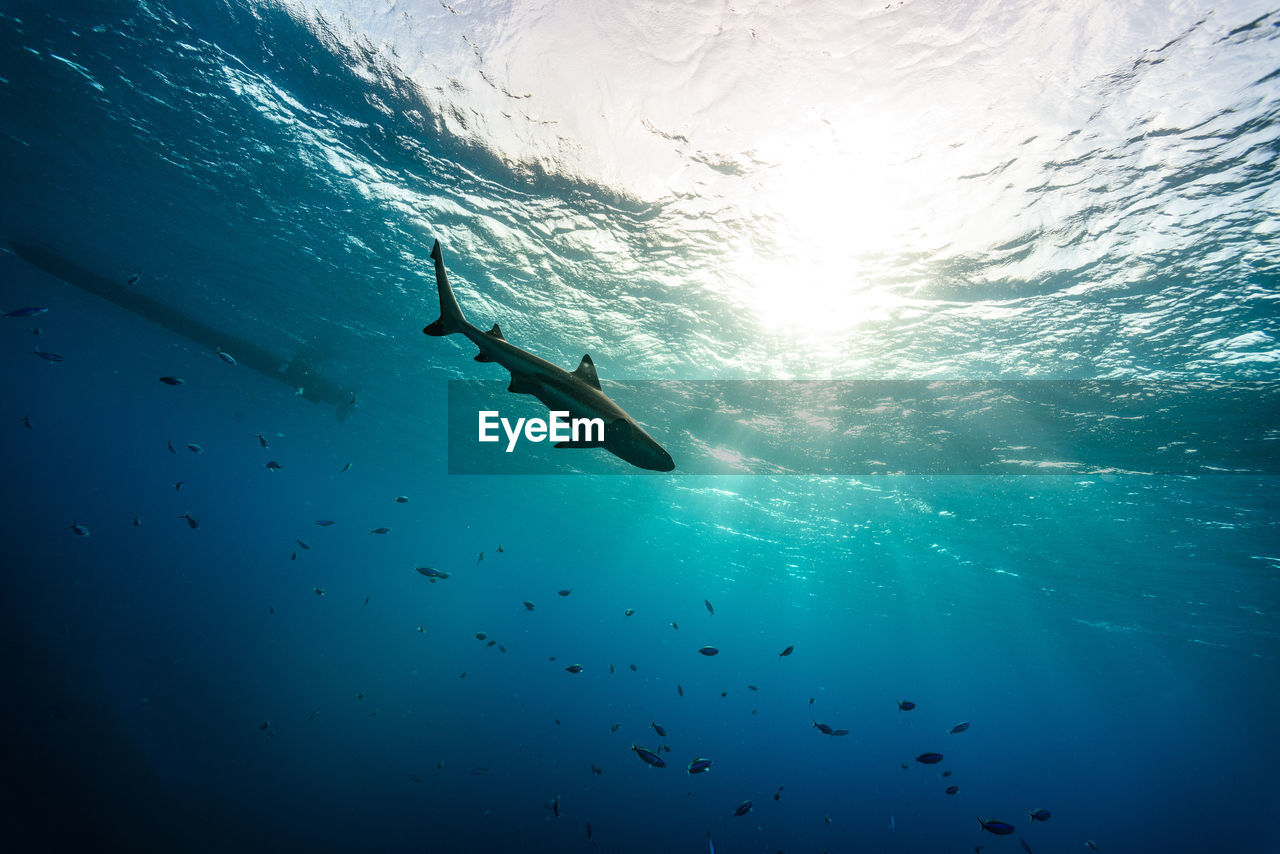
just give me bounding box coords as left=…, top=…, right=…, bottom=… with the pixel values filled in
left=422, top=241, right=676, bottom=471
